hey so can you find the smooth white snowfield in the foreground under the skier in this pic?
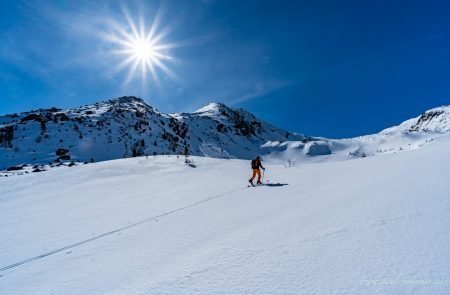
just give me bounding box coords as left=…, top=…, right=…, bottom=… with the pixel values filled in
left=0, top=136, right=450, bottom=295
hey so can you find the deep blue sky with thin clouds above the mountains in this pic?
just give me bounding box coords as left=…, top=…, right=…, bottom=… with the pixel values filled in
left=0, top=0, right=450, bottom=137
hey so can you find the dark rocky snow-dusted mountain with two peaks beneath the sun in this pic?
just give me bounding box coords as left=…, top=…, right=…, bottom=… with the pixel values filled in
left=0, top=97, right=310, bottom=169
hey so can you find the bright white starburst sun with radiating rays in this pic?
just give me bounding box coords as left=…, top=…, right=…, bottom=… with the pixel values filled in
left=106, top=6, right=180, bottom=84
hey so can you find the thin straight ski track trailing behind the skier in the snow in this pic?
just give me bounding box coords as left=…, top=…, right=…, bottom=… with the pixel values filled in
left=0, top=187, right=247, bottom=277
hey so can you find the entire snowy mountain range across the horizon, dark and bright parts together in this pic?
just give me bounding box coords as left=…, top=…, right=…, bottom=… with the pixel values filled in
left=0, top=97, right=450, bottom=171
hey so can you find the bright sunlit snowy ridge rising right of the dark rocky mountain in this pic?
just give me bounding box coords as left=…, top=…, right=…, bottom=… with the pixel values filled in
left=263, top=106, right=450, bottom=163
